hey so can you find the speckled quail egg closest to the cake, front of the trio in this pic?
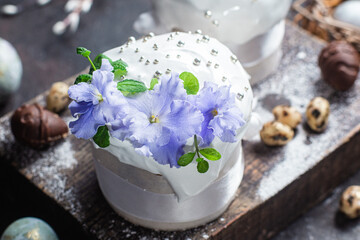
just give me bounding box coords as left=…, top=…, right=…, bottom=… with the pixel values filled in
left=260, top=121, right=294, bottom=146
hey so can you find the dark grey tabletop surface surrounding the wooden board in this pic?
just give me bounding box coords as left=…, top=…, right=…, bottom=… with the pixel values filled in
left=0, top=0, right=360, bottom=240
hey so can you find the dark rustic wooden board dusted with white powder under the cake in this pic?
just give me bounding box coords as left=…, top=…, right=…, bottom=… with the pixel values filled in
left=0, top=23, right=360, bottom=239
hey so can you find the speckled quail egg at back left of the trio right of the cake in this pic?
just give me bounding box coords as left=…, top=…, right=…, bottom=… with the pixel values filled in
left=273, top=105, right=301, bottom=128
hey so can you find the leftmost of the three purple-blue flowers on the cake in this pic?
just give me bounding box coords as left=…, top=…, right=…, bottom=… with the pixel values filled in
left=69, top=59, right=126, bottom=139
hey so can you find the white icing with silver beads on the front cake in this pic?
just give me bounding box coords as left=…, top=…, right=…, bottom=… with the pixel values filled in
left=100, top=33, right=253, bottom=200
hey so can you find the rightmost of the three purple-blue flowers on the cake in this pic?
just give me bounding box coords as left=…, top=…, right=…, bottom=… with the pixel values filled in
left=189, top=82, right=245, bottom=146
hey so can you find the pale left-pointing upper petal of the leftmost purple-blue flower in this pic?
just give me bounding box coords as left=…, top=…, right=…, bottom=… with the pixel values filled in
left=69, top=82, right=100, bottom=105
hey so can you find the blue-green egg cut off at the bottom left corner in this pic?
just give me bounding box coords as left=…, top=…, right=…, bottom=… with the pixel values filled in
left=0, top=217, right=59, bottom=240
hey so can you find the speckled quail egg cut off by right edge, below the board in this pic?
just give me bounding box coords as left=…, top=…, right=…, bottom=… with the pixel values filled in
left=340, top=185, right=360, bottom=218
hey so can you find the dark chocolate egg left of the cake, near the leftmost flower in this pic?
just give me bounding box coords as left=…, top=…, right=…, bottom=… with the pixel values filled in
left=11, top=103, right=68, bottom=149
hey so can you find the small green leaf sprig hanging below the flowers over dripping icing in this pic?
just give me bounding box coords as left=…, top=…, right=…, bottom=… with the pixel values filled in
left=178, top=135, right=221, bottom=173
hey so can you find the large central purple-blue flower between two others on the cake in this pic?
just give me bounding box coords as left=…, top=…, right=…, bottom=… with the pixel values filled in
left=121, top=74, right=204, bottom=166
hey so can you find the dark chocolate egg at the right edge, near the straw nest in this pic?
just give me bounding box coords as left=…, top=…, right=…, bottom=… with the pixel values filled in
left=319, top=41, right=360, bottom=91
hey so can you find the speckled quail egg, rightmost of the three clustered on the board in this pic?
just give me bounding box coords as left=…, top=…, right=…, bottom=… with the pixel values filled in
left=306, top=97, right=330, bottom=132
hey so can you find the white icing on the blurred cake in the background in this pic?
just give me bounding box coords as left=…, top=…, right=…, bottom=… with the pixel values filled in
left=149, top=0, right=292, bottom=44
